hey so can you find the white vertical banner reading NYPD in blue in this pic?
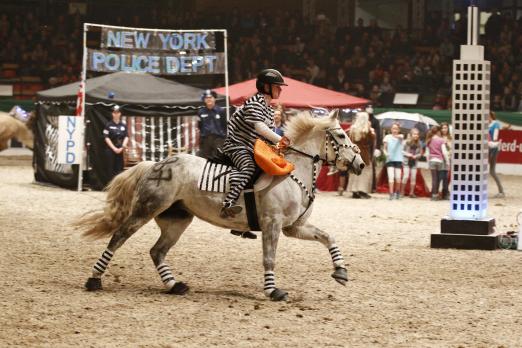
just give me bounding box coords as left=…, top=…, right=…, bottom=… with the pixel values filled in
left=58, top=116, right=83, bottom=164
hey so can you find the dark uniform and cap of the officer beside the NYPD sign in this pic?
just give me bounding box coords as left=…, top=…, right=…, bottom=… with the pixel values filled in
left=103, top=105, right=128, bottom=178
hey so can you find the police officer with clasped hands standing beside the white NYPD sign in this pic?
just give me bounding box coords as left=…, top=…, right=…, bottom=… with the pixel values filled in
left=103, top=105, right=129, bottom=179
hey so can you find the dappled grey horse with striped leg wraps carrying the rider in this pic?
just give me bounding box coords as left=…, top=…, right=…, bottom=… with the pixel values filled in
left=75, top=112, right=364, bottom=301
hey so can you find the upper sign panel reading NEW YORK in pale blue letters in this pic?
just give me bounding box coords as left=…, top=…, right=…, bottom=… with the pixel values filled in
left=101, top=27, right=216, bottom=51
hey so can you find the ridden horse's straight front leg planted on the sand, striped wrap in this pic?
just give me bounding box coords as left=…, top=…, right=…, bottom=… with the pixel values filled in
left=263, top=219, right=288, bottom=301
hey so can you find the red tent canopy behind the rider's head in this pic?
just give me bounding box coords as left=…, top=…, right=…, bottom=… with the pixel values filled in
left=215, top=77, right=369, bottom=109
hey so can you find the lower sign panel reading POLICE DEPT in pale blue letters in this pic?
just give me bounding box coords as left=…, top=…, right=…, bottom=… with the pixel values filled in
left=87, top=49, right=225, bottom=75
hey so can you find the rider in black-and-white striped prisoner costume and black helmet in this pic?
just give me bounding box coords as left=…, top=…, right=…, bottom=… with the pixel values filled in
left=221, top=69, right=290, bottom=217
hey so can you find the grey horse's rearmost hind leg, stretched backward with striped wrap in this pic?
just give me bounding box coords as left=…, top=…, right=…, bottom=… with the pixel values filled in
left=85, top=216, right=150, bottom=291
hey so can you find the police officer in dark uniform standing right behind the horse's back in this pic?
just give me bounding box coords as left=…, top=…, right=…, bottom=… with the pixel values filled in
left=198, top=89, right=227, bottom=158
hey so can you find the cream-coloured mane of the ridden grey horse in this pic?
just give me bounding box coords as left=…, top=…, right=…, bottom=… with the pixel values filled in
left=285, top=111, right=335, bottom=145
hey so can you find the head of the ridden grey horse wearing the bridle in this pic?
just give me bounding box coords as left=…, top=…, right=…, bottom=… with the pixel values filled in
left=318, top=110, right=365, bottom=175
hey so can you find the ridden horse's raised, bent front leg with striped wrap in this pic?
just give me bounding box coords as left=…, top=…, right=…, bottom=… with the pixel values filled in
left=283, top=224, right=348, bottom=285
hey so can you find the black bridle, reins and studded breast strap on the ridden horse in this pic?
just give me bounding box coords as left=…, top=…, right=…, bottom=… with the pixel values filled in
left=288, top=127, right=361, bottom=220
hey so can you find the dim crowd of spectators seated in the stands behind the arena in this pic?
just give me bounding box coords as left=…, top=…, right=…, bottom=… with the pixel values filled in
left=0, top=9, right=522, bottom=111
